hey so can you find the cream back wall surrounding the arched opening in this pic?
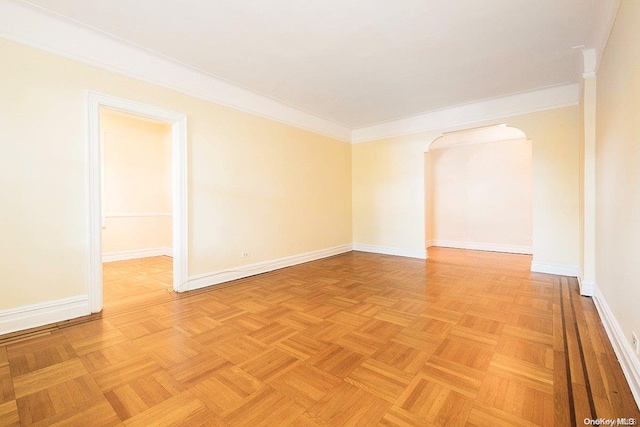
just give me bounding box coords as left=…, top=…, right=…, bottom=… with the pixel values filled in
left=353, top=105, right=580, bottom=269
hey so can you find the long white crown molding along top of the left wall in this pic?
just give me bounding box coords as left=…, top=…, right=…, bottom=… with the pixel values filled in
left=0, top=0, right=351, bottom=142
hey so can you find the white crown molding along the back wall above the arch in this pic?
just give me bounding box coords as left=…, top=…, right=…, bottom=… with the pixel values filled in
left=351, top=83, right=580, bottom=143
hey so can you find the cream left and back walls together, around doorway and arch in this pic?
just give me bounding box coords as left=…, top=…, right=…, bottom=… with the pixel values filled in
left=0, top=36, right=579, bottom=309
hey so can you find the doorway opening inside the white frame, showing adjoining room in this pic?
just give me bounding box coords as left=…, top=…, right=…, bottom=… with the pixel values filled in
left=100, top=107, right=173, bottom=311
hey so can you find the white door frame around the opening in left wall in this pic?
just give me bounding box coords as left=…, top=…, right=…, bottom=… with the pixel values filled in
left=86, top=91, right=188, bottom=313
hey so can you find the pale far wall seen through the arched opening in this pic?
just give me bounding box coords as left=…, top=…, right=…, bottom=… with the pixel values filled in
left=429, top=139, right=532, bottom=251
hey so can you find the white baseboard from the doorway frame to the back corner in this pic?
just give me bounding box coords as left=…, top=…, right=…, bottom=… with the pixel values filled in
left=178, top=244, right=353, bottom=292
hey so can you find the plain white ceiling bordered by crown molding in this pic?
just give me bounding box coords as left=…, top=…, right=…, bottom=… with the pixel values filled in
left=15, top=0, right=605, bottom=129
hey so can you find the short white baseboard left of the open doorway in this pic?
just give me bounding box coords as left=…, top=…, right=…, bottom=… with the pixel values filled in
left=0, top=295, right=91, bottom=335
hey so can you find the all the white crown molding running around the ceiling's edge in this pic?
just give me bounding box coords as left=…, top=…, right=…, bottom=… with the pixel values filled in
left=0, top=0, right=596, bottom=143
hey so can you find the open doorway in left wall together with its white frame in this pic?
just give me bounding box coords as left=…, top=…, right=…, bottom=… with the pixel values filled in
left=87, top=92, right=187, bottom=313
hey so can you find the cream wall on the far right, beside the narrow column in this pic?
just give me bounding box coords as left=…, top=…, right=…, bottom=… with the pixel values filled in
left=596, top=0, right=640, bottom=354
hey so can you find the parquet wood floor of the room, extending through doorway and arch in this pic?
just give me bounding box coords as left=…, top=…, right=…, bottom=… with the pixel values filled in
left=0, top=248, right=640, bottom=426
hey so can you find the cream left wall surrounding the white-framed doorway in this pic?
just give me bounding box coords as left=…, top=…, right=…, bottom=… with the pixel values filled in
left=0, top=41, right=352, bottom=310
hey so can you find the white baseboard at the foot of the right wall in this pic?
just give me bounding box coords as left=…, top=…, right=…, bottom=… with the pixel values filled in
left=593, top=284, right=640, bottom=408
